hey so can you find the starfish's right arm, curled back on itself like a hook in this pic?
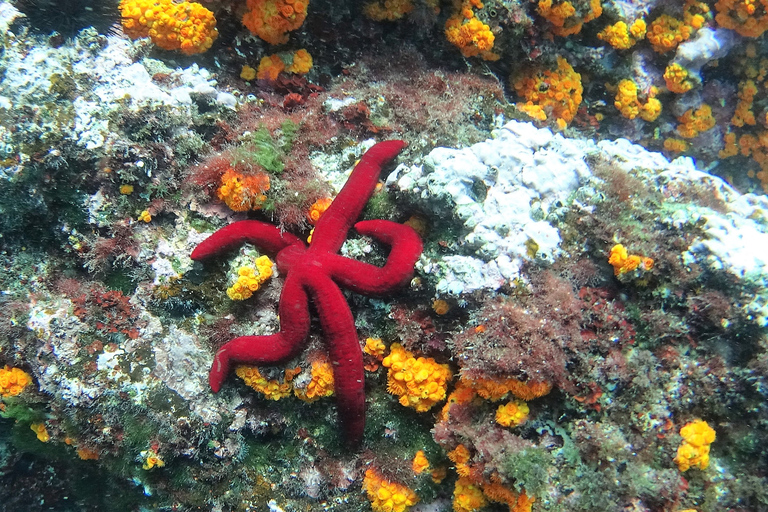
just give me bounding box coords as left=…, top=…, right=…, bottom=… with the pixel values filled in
left=327, top=220, right=423, bottom=295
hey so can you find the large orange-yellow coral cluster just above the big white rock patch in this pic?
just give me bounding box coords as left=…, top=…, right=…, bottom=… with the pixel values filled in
left=512, top=57, right=584, bottom=128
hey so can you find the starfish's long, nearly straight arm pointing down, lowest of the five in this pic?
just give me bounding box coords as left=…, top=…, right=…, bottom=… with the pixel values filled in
left=307, top=273, right=365, bottom=446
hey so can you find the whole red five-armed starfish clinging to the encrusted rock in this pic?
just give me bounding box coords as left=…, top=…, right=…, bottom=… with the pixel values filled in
left=192, top=140, right=422, bottom=444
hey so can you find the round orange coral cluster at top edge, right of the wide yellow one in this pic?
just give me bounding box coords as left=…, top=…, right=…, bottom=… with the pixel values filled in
left=243, top=0, right=309, bottom=44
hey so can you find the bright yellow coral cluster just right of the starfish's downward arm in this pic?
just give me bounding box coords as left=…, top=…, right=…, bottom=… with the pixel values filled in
left=381, top=343, right=451, bottom=412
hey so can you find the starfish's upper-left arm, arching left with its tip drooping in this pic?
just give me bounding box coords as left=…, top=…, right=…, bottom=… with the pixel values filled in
left=191, top=220, right=303, bottom=261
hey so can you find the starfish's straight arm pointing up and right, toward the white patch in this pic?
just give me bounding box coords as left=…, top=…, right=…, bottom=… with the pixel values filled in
left=310, top=140, right=405, bottom=253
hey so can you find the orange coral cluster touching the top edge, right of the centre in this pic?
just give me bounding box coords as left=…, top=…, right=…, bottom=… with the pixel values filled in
left=445, top=0, right=499, bottom=60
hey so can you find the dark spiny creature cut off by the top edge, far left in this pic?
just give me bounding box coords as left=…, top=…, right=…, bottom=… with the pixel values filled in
left=16, top=0, right=120, bottom=38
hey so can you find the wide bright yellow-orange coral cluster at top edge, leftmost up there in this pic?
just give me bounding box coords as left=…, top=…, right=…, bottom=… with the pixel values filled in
left=120, top=0, right=219, bottom=55
